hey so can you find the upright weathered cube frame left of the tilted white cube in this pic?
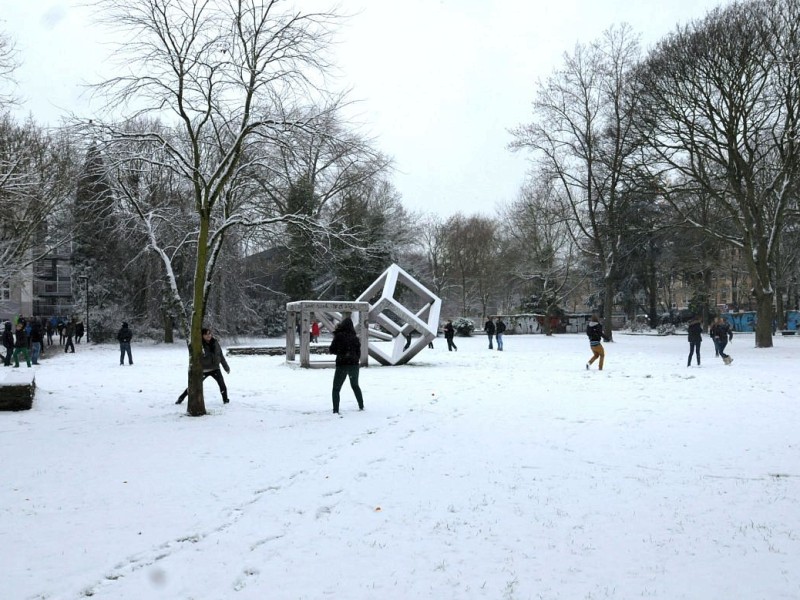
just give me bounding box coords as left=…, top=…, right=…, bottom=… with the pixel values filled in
left=286, top=300, right=369, bottom=368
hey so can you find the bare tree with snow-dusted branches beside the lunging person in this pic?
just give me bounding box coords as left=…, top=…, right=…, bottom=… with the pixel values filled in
left=93, top=0, right=336, bottom=416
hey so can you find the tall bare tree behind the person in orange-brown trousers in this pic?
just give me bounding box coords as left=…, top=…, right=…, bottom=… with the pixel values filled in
left=511, top=25, right=639, bottom=339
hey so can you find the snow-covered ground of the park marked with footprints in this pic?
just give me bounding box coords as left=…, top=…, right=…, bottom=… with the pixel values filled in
left=0, top=332, right=800, bottom=600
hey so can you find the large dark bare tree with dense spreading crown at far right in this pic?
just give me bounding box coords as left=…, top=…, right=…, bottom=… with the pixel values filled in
left=639, top=0, right=800, bottom=348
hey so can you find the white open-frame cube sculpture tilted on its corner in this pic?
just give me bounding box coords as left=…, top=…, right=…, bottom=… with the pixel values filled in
left=357, top=264, right=442, bottom=365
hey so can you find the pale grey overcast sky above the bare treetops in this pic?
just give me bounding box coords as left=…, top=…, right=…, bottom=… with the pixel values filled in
left=0, top=0, right=730, bottom=216
